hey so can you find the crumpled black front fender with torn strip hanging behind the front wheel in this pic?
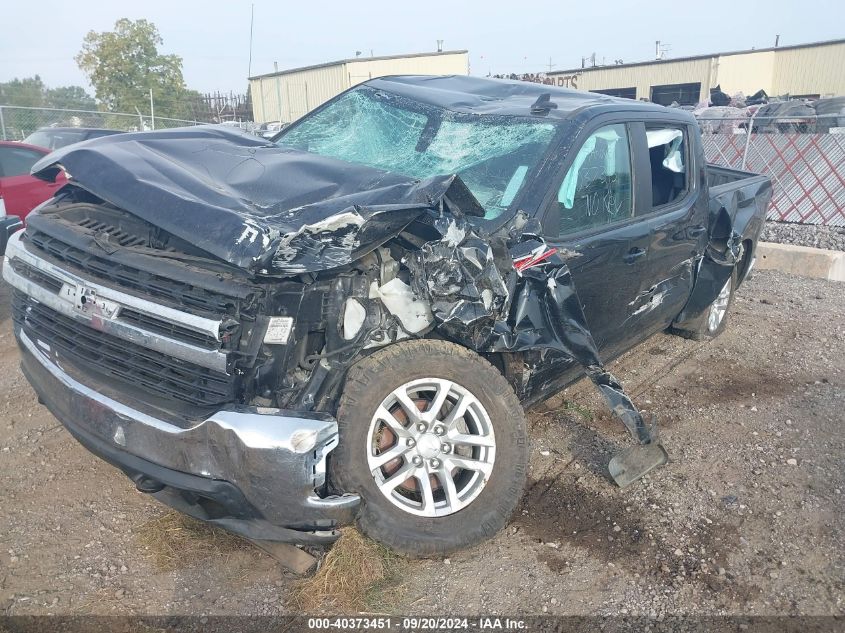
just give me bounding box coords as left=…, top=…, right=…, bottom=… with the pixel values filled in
left=408, top=219, right=656, bottom=444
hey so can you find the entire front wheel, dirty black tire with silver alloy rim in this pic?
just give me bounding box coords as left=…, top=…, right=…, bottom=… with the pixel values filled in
left=330, top=340, right=529, bottom=557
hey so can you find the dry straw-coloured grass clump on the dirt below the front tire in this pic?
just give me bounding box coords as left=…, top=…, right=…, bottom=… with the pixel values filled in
left=291, top=528, right=407, bottom=613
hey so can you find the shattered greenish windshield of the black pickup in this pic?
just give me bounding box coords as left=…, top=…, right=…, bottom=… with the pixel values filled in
left=276, top=87, right=555, bottom=220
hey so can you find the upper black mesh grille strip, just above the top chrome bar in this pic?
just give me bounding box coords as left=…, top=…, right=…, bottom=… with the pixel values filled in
left=26, top=230, right=238, bottom=314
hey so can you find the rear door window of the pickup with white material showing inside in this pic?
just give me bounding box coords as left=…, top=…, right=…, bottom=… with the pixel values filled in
left=646, top=126, right=688, bottom=207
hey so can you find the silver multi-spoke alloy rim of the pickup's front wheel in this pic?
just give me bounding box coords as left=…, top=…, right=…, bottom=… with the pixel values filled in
left=367, top=378, right=496, bottom=517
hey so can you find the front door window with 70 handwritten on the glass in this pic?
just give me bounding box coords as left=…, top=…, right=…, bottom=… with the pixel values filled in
left=557, top=124, right=634, bottom=235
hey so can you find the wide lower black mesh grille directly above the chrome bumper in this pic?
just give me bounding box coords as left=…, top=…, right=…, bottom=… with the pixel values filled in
left=12, top=291, right=236, bottom=407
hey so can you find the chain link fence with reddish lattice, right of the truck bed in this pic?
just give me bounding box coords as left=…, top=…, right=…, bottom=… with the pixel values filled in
left=699, top=115, right=845, bottom=226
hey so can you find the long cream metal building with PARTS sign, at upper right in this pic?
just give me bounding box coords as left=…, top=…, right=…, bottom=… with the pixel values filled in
left=547, top=39, right=845, bottom=105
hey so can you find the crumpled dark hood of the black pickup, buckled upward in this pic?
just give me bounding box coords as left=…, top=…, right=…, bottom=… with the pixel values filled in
left=32, top=126, right=484, bottom=274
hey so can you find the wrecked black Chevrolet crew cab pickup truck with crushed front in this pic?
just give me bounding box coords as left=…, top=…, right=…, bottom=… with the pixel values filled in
left=3, top=77, right=771, bottom=555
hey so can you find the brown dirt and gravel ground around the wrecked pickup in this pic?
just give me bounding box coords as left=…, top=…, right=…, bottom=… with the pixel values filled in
left=0, top=271, right=845, bottom=617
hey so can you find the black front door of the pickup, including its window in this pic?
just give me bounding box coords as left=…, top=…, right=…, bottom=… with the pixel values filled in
left=527, top=121, right=652, bottom=393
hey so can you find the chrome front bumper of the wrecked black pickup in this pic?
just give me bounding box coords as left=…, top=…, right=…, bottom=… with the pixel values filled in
left=16, top=328, right=360, bottom=544
